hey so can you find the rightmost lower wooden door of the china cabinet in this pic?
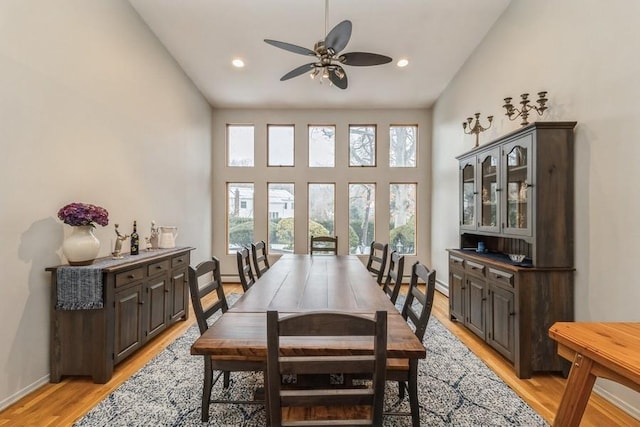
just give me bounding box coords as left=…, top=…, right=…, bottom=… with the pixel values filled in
left=487, top=285, right=516, bottom=362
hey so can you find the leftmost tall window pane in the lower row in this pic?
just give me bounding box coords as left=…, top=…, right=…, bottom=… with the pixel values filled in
left=227, top=183, right=253, bottom=254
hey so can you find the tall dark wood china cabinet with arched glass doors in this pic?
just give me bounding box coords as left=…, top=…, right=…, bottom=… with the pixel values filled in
left=449, top=122, right=576, bottom=378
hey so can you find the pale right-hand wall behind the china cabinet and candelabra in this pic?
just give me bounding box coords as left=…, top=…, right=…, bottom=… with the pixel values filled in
left=432, top=0, right=640, bottom=418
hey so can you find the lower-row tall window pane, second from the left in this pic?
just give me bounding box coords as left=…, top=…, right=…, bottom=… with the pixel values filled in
left=269, top=184, right=295, bottom=254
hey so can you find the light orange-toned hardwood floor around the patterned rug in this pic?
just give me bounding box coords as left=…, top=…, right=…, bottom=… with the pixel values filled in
left=0, top=284, right=640, bottom=427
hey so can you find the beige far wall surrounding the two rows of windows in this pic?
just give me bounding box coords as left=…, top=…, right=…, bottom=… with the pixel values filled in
left=213, top=109, right=431, bottom=277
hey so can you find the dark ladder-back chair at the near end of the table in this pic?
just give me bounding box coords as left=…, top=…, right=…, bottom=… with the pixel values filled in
left=267, top=311, right=387, bottom=427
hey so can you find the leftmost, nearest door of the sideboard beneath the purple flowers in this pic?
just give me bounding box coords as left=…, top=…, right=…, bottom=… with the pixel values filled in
left=114, top=284, right=144, bottom=363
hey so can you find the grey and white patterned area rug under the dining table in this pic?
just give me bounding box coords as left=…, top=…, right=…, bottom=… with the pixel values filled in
left=75, top=295, right=547, bottom=427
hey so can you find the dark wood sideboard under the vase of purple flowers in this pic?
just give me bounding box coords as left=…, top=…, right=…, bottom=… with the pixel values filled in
left=46, top=247, right=193, bottom=384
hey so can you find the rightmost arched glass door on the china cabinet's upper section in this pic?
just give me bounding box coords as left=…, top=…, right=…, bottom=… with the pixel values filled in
left=501, top=134, right=534, bottom=236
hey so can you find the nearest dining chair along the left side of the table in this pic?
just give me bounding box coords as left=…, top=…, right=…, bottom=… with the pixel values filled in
left=189, top=257, right=266, bottom=421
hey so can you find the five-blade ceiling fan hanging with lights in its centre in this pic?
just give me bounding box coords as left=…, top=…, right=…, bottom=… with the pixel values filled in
left=264, top=0, right=392, bottom=89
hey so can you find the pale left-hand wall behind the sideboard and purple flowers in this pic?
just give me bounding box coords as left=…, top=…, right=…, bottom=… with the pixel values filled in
left=0, top=0, right=211, bottom=409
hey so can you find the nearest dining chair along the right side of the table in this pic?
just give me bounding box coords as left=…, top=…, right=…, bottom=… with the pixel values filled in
left=385, top=262, right=436, bottom=427
